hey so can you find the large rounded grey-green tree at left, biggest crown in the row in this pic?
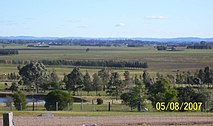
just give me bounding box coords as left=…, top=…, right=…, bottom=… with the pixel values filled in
left=18, top=62, right=49, bottom=93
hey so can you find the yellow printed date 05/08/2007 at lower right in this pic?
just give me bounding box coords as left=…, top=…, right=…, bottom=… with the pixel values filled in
left=155, top=102, right=203, bottom=111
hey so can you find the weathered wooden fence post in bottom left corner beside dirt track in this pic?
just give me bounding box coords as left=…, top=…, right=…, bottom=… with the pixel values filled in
left=3, top=112, right=14, bottom=126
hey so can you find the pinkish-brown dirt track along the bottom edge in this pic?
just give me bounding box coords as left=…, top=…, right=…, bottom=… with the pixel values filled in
left=0, top=116, right=213, bottom=126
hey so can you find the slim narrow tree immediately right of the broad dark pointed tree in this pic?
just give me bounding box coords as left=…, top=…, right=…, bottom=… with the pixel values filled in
left=83, top=71, right=92, bottom=95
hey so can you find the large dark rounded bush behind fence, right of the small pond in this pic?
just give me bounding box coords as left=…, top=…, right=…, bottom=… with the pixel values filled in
left=44, top=90, right=72, bottom=111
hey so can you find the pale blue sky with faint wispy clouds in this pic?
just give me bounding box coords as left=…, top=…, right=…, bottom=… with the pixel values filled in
left=0, top=0, right=213, bottom=38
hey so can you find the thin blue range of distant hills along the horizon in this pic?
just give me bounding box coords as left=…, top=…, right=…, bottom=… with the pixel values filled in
left=0, top=36, right=213, bottom=43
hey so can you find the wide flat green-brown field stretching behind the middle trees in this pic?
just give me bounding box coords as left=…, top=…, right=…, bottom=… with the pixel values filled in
left=0, top=46, right=213, bottom=76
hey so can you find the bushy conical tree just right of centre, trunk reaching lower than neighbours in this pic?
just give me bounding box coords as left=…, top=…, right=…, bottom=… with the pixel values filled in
left=107, top=72, right=125, bottom=100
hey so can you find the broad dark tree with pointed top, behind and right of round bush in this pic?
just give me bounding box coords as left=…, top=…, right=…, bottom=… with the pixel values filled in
left=65, top=67, right=83, bottom=95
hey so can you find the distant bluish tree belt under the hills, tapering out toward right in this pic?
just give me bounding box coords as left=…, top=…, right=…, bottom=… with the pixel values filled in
left=0, top=38, right=153, bottom=46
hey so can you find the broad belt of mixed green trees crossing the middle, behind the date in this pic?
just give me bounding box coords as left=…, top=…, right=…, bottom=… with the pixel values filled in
left=6, top=62, right=213, bottom=111
